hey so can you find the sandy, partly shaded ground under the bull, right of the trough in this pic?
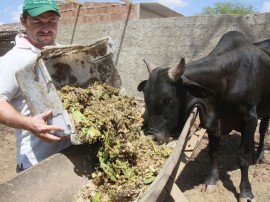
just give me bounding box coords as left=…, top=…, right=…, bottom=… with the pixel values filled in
left=177, top=133, right=270, bottom=202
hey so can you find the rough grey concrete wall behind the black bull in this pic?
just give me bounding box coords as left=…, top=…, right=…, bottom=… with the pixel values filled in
left=58, top=13, right=270, bottom=97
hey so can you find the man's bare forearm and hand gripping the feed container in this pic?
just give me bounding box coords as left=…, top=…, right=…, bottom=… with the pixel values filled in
left=0, top=100, right=64, bottom=142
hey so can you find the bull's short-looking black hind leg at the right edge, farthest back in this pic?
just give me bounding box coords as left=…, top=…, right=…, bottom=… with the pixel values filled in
left=256, top=117, right=269, bottom=163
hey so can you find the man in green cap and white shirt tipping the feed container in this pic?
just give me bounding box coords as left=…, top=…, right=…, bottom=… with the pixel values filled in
left=0, top=0, right=71, bottom=172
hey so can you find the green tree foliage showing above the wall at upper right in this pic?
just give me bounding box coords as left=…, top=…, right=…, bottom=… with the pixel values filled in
left=197, top=2, right=255, bottom=15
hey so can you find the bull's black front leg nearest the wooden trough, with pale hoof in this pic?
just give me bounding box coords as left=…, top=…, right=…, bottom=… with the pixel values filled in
left=203, top=132, right=220, bottom=193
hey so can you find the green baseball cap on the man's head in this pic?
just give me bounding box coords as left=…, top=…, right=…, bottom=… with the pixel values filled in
left=23, top=0, right=60, bottom=17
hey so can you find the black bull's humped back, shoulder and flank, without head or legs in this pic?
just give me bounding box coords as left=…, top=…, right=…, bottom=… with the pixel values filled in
left=184, top=31, right=270, bottom=122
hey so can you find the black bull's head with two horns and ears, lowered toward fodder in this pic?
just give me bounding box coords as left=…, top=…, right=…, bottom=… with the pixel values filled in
left=138, top=58, right=213, bottom=143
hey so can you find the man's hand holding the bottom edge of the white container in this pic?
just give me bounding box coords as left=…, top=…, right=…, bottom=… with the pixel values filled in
left=30, top=110, right=64, bottom=142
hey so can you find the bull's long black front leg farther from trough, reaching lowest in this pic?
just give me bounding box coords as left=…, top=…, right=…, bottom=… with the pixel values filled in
left=237, top=107, right=258, bottom=202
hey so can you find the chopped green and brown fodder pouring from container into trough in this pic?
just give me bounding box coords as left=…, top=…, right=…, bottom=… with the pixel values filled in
left=58, top=83, right=173, bottom=202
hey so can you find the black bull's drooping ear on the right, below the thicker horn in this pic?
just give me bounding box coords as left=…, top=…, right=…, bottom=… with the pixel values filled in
left=183, top=80, right=215, bottom=98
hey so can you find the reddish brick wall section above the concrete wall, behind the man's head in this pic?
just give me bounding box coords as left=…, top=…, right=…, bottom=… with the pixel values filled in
left=58, top=2, right=139, bottom=25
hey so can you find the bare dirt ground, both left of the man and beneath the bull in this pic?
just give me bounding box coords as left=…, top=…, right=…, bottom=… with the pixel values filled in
left=0, top=125, right=270, bottom=202
